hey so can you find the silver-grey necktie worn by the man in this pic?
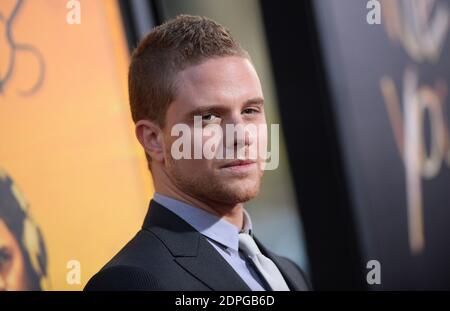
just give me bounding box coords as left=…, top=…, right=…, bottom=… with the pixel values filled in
left=239, top=233, right=289, bottom=291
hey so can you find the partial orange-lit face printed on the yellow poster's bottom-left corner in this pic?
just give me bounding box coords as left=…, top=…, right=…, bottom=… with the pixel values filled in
left=0, top=219, right=31, bottom=291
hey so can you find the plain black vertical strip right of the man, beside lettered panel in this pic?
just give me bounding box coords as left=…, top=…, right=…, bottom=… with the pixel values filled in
left=261, top=0, right=366, bottom=290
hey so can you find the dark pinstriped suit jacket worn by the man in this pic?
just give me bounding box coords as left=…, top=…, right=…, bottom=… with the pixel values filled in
left=84, top=200, right=308, bottom=291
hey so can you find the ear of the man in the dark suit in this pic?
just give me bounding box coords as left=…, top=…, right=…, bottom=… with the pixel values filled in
left=135, top=120, right=164, bottom=162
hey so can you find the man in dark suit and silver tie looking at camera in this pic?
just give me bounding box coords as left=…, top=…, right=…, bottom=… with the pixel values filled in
left=85, top=15, right=307, bottom=291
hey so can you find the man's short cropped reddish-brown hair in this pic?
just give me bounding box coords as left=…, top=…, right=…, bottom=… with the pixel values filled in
left=128, top=15, right=249, bottom=127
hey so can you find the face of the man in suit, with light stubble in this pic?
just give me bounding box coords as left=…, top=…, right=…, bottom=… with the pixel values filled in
left=163, top=56, right=267, bottom=210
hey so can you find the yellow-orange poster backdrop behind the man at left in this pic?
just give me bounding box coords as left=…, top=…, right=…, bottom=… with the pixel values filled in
left=0, top=0, right=153, bottom=290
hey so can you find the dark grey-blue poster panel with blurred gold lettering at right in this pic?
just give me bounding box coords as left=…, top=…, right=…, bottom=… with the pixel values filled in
left=313, top=0, right=450, bottom=290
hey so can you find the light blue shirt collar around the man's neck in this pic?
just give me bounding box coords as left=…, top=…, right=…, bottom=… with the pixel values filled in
left=153, top=192, right=253, bottom=251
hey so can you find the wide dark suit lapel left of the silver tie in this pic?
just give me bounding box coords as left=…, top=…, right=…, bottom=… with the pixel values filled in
left=143, top=200, right=251, bottom=291
